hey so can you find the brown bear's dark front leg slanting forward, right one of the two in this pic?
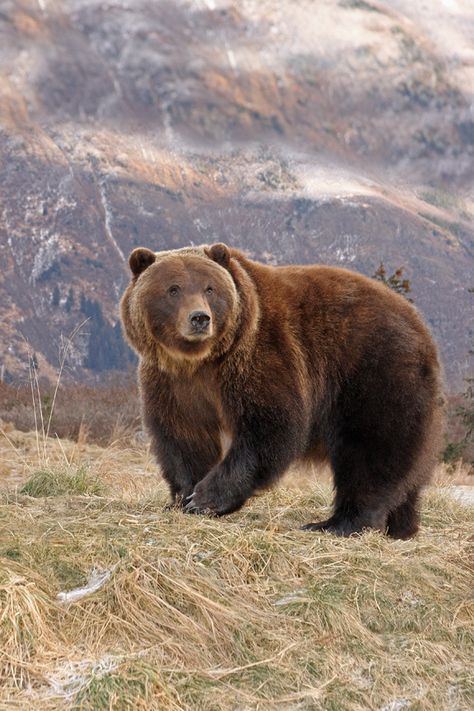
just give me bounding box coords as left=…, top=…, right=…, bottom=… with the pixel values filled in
left=186, top=411, right=298, bottom=516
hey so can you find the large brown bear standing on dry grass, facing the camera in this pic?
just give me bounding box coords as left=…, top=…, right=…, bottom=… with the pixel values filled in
left=121, top=244, right=443, bottom=538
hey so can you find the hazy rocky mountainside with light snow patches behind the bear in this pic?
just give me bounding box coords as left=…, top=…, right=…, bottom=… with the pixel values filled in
left=0, top=0, right=474, bottom=389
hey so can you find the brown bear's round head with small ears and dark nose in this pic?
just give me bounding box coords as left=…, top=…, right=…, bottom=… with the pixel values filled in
left=122, top=244, right=239, bottom=369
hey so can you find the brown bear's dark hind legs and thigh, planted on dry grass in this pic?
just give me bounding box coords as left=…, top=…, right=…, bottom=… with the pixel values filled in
left=307, top=364, right=441, bottom=538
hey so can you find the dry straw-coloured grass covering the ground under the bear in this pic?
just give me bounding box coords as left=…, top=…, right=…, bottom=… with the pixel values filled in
left=0, top=432, right=474, bottom=711
